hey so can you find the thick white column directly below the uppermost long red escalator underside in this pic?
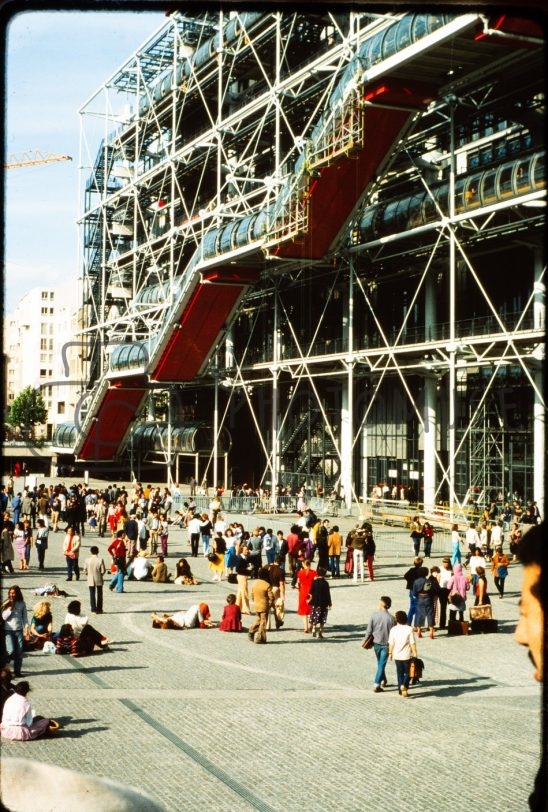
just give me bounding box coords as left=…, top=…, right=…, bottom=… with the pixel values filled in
left=340, top=259, right=354, bottom=511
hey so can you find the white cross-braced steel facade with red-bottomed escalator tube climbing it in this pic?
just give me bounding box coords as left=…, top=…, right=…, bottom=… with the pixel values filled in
left=70, top=8, right=546, bottom=511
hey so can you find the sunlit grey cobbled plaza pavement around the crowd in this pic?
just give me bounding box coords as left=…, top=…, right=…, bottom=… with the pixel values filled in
left=2, top=482, right=541, bottom=812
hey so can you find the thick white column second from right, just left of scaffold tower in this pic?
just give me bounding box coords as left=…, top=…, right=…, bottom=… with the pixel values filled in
left=422, top=273, right=438, bottom=511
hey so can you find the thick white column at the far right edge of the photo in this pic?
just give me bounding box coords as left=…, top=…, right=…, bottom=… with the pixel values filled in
left=533, top=250, right=546, bottom=518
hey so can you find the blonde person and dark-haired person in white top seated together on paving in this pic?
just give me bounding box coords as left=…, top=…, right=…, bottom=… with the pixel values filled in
left=25, top=600, right=109, bottom=657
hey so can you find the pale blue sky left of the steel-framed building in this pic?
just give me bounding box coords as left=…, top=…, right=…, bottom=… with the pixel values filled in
left=4, top=8, right=165, bottom=313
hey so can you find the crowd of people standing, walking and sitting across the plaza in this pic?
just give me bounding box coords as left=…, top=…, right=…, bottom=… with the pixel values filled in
left=1, top=476, right=538, bottom=804
